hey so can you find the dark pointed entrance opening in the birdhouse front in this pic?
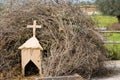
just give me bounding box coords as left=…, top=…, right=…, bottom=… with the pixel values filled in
left=25, top=60, right=39, bottom=76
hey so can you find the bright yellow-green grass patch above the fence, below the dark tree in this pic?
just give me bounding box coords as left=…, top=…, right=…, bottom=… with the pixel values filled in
left=92, top=15, right=117, bottom=27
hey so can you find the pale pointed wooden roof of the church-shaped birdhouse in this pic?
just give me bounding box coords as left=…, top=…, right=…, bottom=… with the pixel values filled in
left=19, top=36, right=43, bottom=50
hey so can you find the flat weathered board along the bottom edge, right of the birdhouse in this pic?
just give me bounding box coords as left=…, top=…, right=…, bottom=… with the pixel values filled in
left=35, top=76, right=84, bottom=80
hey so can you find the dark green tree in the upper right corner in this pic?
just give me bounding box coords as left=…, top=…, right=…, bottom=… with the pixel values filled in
left=96, top=0, right=120, bottom=23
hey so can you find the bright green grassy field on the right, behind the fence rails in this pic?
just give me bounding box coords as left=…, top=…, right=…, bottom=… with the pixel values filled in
left=92, top=15, right=120, bottom=59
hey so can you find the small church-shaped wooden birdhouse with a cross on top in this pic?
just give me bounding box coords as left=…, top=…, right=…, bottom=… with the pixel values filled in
left=19, top=20, right=43, bottom=76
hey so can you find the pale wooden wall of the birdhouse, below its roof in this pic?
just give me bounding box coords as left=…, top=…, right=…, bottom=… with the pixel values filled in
left=21, top=49, right=41, bottom=69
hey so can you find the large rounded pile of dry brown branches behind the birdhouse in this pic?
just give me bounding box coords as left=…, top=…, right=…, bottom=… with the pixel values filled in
left=0, top=3, right=107, bottom=78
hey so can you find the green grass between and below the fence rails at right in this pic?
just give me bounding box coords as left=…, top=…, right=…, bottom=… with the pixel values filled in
left=105, top=33, right=120, bottom=60
